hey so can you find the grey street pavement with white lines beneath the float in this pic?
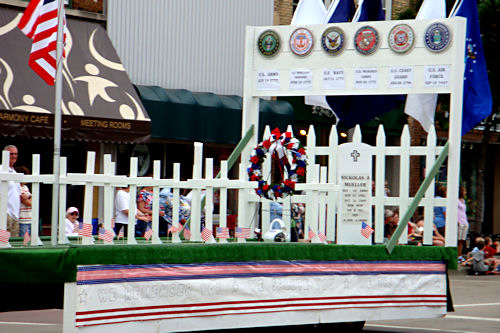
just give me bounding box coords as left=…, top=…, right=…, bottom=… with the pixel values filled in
left=0, top=269, right=500, bottom=333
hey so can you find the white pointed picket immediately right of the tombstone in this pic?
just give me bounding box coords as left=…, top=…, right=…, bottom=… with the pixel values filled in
left=372, top=125, right=386, bottom=244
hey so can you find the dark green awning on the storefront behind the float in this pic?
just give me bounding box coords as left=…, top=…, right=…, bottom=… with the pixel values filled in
left=135, top=85, right=294, bottom=144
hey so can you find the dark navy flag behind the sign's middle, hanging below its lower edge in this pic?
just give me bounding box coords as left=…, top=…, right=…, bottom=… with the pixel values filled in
left=326, top=0, right=406, bottom=128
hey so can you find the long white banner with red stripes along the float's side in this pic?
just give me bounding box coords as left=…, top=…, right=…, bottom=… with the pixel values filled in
left=71, top=260, right=446, bottom=333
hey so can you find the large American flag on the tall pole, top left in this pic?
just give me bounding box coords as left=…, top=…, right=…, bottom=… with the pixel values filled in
left=17, top=0, right=66, bottom=86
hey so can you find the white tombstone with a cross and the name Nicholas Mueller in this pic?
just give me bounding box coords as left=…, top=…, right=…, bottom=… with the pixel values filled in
left=337, top=142, right=372, bottom=245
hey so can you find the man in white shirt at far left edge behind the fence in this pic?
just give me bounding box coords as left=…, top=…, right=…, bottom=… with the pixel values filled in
left=4, top=145, right=21, bottom=237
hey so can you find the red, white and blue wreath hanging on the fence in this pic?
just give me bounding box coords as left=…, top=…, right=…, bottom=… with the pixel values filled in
left=247, top=128, right=307, bottom=200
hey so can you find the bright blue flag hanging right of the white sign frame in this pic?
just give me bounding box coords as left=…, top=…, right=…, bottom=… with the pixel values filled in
left=451, top=0, right=493, bottom=135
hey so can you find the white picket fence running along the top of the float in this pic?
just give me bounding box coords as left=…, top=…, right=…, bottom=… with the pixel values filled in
left=0, top=126, right=456, bottom=247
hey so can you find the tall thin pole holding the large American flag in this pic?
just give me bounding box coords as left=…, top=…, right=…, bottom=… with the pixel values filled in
left=50, top=0, right=64, bottom=245
